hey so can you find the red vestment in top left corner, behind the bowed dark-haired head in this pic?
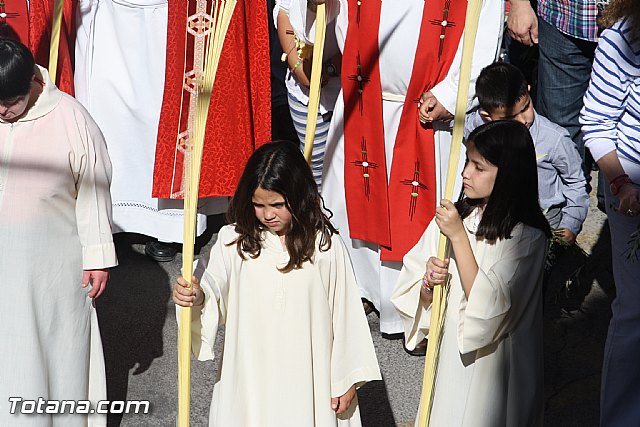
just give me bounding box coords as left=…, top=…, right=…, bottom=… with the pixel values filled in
left=0, top=0, right=76, bottom=95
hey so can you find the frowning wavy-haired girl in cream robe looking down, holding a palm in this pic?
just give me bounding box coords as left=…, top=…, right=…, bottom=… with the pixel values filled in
left=173, top=141, right=380, bottom=427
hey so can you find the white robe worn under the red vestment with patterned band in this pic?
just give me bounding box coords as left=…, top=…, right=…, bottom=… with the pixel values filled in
left=74, top=0, right=227, bottom=242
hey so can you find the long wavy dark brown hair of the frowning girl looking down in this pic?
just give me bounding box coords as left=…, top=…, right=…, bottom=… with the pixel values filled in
left=227, top=141, right=337, bottom=273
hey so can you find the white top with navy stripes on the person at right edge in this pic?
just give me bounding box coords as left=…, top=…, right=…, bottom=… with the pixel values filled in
left=580, top=18, right=640, bottom=165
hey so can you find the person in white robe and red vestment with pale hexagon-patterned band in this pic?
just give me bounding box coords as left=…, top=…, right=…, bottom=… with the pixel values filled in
left=75, top=0, right=270, bottom=261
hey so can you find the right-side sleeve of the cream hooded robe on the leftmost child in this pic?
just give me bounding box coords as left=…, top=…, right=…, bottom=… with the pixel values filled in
left=72, top=103, right=118, bottom=270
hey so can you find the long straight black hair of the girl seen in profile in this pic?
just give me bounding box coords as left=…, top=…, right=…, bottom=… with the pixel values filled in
left=456, top=120, right=551, bottom=241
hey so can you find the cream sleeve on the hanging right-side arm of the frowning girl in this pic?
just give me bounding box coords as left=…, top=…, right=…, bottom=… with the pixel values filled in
left=329, top=235, right=382, bottom=397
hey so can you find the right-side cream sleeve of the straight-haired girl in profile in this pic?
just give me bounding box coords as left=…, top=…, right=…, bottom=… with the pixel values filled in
left=457, top=225, right=547, bottom=354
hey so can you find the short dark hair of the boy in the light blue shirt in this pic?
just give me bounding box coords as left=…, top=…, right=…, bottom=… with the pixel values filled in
left=476, top=62, right=529, bottom=113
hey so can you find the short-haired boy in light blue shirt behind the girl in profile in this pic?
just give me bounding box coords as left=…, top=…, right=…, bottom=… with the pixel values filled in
left=465, top=62, right=589, bottom=243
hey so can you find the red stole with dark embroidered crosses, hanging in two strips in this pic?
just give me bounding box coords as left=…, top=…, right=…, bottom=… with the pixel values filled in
left=342, top=0, right=467, bottom=261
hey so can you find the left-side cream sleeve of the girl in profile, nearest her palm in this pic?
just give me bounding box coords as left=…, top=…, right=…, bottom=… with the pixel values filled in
left=391, top=220, right=440, bottom=350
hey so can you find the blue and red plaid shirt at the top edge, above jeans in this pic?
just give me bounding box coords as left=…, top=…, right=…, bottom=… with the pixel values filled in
left=538, top=0, right=608, bottom=42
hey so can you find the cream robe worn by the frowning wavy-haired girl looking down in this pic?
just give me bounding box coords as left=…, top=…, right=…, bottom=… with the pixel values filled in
left=185, top=225, right=381, bottom=427
